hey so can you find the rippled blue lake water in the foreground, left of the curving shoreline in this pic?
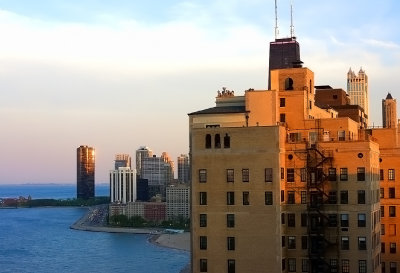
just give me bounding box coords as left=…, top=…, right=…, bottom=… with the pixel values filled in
left=0, top=184, right=189, bottom=273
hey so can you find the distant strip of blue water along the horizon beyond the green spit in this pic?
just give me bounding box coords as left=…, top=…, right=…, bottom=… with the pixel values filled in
left=0, top=184, right=110, bottom=199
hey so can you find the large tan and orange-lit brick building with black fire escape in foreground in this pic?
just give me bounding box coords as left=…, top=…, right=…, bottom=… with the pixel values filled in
left=189, top=68, right=380, bottom=273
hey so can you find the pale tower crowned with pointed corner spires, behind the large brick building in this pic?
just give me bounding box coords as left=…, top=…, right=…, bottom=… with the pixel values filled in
left=347, top=68, right=369, bottom=125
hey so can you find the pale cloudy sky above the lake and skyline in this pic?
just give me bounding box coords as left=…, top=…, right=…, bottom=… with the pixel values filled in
left=0, top=0, right=400, bottom=184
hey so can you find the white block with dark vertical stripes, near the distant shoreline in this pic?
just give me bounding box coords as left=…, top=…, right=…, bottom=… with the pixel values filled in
left=110, top=167, right=137, bottom=204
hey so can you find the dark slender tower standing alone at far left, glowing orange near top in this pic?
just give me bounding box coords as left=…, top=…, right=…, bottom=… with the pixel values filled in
left=76, top=146, right=95, bottom=199
